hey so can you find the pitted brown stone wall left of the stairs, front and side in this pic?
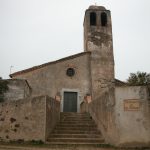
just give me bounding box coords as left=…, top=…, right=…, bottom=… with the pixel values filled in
left=0, top=96, right=60, bottom=141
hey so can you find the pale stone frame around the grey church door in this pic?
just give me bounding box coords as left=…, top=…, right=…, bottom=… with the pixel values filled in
left=60, top=88, right=80, bottom=112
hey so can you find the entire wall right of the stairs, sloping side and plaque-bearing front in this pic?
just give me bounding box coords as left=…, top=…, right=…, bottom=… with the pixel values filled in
left=84, top=86, right=150, bottom=147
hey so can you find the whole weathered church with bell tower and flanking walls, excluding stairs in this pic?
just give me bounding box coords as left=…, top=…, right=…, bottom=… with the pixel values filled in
left=0, top=6, right=150, bottom=146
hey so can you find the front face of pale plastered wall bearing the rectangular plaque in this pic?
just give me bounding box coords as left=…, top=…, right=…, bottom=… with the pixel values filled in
left=115, top=86, right=150, bottom=146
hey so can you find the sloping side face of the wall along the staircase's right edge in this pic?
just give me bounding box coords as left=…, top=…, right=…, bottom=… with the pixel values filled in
left=84, top=88, right=118, bottom=144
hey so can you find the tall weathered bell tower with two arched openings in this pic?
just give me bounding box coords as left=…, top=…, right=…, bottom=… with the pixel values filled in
left=84, top=6, right=114, bottom=99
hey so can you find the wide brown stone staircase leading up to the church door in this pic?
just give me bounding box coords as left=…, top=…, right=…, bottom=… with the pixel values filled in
left=47, top=112, right=104, bottom=144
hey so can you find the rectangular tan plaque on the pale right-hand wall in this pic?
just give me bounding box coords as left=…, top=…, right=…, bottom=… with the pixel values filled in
left=124, top=99, right=140, bottom=111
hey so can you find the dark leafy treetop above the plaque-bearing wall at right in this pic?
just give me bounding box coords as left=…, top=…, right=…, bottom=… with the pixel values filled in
left=127, top=71, right=150, bottom=85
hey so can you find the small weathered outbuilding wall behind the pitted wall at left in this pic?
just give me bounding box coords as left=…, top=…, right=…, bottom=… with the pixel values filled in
left=4, top=79, right=31, bottom=101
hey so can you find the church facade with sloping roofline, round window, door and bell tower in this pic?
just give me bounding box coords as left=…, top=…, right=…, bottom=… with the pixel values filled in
left=10, top=6, right=114, bottom=112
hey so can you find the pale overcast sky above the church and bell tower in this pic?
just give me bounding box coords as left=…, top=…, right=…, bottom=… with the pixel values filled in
left=0, top=0, right=150, bottom=81
